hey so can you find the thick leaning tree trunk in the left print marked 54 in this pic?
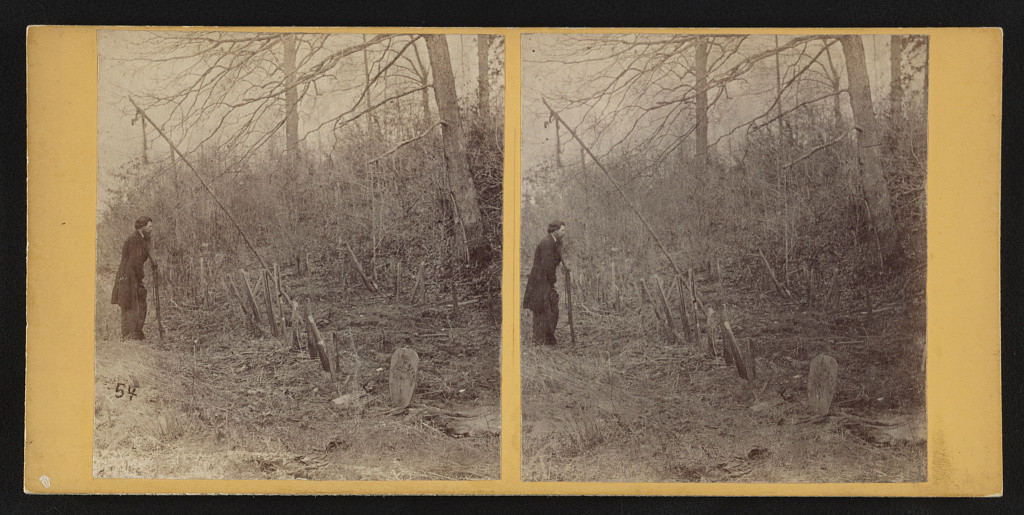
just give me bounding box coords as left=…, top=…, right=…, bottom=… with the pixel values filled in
left=424, top=34, right=489, bottom=262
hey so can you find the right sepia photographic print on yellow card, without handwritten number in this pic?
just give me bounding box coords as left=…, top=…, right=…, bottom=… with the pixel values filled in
left=519, top=33, right=929, bottom=483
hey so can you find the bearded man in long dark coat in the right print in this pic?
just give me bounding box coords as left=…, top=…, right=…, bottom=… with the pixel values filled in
left=522, top=220, right=565, bottom=345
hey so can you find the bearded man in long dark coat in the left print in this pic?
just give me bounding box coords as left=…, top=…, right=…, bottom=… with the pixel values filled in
left=111, top=216, right=157, bottom=340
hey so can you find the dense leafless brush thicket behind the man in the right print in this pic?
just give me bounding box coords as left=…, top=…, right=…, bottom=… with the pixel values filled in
left=520, top=100, right=927, bottom=317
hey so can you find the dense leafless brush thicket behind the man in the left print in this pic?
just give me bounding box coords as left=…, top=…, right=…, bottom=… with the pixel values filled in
left=96, top=108, right=504, bottom=302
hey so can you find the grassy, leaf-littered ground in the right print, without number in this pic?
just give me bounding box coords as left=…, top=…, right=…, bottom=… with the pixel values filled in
left=520, top=270, right=928, bottom=482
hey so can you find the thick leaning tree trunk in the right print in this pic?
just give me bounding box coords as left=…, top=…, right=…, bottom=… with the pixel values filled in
left=839, top=36, right=895, bottom=255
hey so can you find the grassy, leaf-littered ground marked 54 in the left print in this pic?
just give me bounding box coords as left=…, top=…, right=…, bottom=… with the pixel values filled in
left=93, top=264, right=501, bottom=480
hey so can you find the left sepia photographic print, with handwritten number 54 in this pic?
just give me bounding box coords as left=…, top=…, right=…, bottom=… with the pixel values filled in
left=92, top=30, right=505, bottom=480
